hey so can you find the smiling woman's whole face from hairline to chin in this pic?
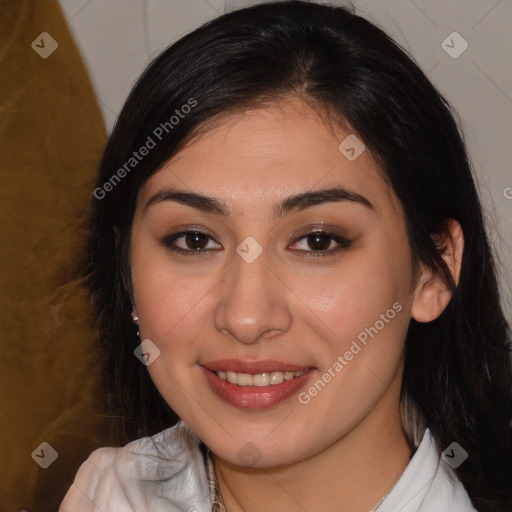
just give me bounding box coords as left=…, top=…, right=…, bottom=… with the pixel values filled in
left=131, top=98, right=413, bottom=467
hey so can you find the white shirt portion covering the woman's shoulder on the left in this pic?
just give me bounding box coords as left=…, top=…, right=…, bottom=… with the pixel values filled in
left=59, top=422, right=210, bottom=512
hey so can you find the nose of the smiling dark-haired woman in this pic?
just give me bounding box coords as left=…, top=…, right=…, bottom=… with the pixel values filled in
left=214, top=244, right=292, bottom=344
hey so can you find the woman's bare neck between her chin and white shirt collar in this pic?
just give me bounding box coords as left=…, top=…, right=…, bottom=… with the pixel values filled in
left=212, top=380, right=411, bottom=512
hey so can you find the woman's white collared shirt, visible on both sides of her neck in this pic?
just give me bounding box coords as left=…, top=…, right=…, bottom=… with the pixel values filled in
left=59, top=420, right=477, bottom=512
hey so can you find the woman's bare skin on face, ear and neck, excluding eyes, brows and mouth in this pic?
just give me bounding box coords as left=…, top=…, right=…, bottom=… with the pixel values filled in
left=131, top=97, right=463, bottom=512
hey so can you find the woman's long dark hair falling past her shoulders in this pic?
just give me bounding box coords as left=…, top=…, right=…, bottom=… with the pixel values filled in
left=81, top=1, right=512, bottom=512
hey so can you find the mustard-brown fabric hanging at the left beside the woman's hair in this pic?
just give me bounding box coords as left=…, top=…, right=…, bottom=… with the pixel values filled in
left=0, top=0, right=115, bottom=512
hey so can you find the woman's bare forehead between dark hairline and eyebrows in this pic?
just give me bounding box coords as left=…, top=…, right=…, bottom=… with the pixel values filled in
left=139, top=97, right=396, bottom=214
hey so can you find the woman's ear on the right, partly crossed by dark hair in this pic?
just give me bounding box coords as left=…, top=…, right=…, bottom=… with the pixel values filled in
left=411, top=219, right=464, bottom=322
